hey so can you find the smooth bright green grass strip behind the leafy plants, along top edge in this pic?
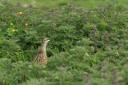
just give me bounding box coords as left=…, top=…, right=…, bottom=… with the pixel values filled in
left=6, top=0, right=128, bottom=8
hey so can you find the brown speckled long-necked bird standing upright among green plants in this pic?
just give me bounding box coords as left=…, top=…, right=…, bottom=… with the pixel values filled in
left=34, top=38, right=50, bottom=64
